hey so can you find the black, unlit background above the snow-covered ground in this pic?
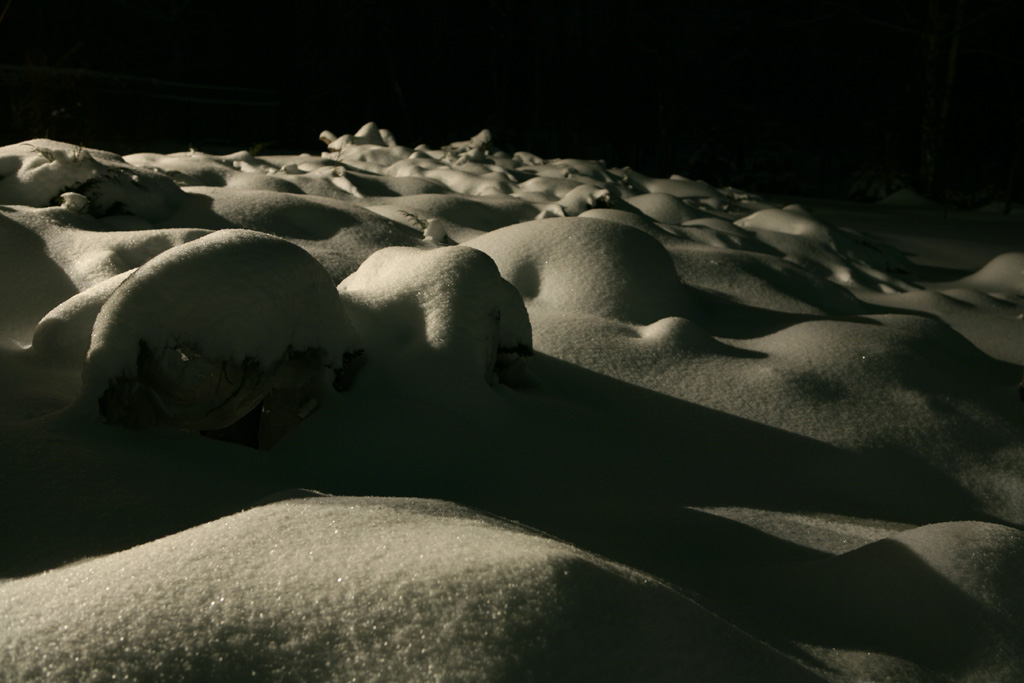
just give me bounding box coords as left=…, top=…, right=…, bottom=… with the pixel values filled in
left=0, top=0, right=1024, bottom=205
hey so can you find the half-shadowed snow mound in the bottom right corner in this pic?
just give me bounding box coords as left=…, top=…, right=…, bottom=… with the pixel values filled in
left=763, top=522, right=1024, bottom=681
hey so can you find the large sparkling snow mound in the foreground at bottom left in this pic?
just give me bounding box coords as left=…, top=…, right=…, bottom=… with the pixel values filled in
left=0, top=498, right=815, bottom=681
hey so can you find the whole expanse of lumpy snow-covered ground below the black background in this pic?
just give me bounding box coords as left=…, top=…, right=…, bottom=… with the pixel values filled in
left=0, top=124, right=1024, bottom=681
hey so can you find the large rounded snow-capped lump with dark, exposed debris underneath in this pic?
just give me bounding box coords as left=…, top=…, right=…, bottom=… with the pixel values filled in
left=79, top=230, right=358, bottom=444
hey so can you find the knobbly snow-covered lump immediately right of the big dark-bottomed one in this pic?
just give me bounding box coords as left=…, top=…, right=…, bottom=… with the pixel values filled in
left=338, top=247, right=532, bottom=382
